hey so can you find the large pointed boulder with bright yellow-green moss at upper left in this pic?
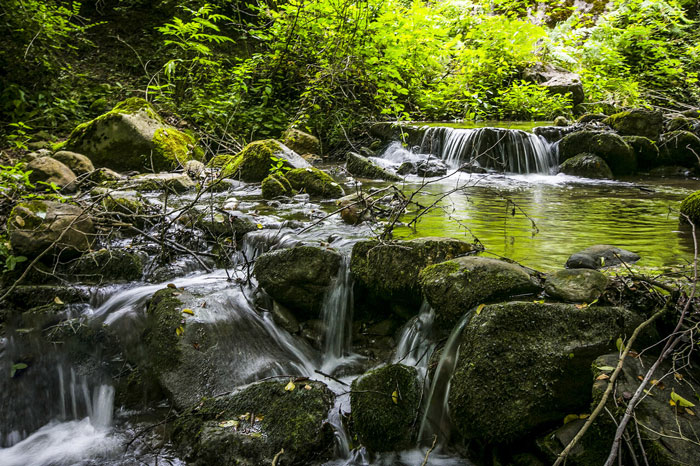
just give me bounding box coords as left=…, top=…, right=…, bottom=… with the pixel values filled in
left=63, top=97, right=201, bottom=171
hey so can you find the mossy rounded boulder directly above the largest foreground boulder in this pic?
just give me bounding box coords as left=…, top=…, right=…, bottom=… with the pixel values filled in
left=420, top=256, right=540, bottom=329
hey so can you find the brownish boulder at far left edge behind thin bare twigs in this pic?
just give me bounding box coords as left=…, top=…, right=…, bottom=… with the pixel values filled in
left=7, top=201, right=95, bottom=257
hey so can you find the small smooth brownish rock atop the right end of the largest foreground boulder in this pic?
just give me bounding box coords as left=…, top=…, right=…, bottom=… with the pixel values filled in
left=544, top=269, right=608, bottom=303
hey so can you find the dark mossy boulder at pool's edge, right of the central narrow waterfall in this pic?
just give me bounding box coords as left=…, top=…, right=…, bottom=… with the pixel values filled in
left=350, top=237, right=479, bottom=318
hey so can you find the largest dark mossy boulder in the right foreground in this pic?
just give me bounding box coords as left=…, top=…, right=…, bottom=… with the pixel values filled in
left=448, top=302, right=641, bottom=443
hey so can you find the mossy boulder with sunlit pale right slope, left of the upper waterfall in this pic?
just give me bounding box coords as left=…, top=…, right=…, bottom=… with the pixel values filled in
left=217, top=139, right=311, bottom=183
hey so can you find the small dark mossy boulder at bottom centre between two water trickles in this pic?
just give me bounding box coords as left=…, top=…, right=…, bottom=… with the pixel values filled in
left=350, top=364, right=421, bottom=451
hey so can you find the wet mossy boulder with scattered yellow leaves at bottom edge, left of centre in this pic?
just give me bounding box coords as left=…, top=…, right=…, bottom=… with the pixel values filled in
left=174, top=381, right=335, bottom=466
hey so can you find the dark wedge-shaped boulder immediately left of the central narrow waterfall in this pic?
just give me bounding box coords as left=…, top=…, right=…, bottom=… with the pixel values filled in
left=253, top=246, right=342, bottom=320
